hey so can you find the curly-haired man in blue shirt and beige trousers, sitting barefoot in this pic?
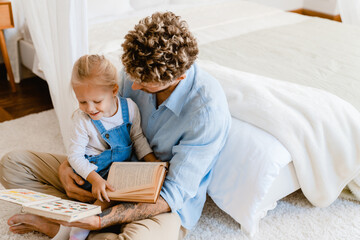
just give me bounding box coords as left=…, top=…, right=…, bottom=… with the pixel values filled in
left=0, top=12, right=231, bottom=240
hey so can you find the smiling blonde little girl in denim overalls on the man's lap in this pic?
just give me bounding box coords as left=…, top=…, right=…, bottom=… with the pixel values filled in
left=68, top=55, right=157, bottom=240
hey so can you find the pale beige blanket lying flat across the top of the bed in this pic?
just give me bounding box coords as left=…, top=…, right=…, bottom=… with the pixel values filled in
left=200, top=18, right=360, bottom=111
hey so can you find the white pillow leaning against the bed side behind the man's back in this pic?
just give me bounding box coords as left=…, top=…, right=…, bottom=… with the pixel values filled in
left=208, top=118, right=291, bottom=236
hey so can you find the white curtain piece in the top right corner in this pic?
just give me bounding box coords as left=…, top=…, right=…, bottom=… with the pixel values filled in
left=338, top=0, right=360, bottom=26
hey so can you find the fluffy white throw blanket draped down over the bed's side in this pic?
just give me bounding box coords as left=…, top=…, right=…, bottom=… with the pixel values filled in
left=200, top=61, right=360, bottom=207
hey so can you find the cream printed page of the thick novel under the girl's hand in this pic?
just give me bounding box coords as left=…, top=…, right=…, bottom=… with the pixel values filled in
left=108, top=162, right=159, bottom=192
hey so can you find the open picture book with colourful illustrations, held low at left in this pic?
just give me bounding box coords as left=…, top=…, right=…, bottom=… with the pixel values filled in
left=0, top=189, right=101, bottom=222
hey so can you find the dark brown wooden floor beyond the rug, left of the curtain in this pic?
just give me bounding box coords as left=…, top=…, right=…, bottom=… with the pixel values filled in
left=0, top=64, right=53, bottom=122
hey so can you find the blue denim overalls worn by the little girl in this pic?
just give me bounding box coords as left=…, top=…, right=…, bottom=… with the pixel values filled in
left=80, top=97, right=132, bottom=191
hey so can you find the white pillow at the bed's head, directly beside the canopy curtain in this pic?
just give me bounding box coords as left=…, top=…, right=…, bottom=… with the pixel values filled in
left=87, top=0, right=133, bottom=21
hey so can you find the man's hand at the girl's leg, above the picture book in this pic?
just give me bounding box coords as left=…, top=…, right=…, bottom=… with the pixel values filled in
left=59, top=161, right=95, bottom=202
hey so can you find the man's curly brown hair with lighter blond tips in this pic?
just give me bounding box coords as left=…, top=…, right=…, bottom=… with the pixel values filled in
left=122, top=12, right=199, bottom=84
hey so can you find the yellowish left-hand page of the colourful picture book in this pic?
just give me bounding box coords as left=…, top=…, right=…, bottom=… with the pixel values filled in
left=0, top=189, right=60, bottom=205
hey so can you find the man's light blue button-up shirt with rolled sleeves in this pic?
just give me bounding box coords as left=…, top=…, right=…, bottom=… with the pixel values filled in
left=120, top=64, right=231, bottom=229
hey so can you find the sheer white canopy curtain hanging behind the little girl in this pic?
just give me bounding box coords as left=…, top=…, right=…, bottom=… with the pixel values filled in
left=22, top=0, right=88, bottom=149
